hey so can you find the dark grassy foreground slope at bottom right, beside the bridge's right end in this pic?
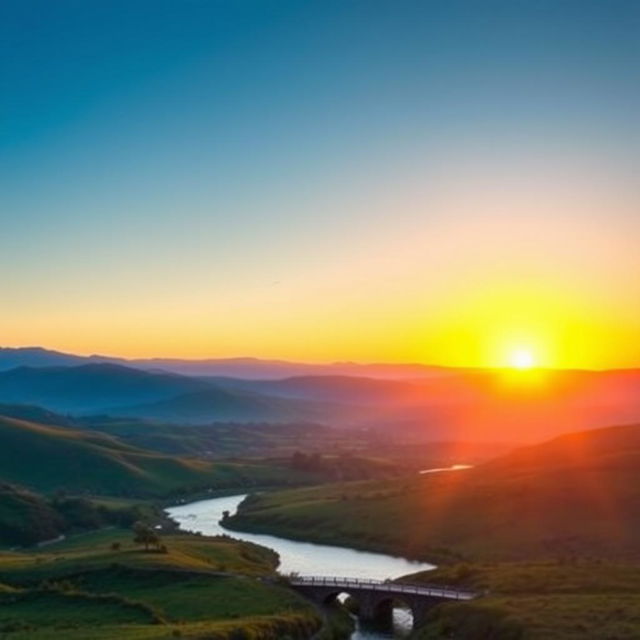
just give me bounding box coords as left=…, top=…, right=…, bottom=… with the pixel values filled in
left=408, top=562, right=640, bottom=640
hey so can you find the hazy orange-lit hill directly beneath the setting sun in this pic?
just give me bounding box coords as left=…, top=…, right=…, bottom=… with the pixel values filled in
left=207, top=369, right=640, bottom=442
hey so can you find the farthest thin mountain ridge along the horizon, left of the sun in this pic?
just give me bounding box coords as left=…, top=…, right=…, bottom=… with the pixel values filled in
left=0, top=347, right=450, bottom=380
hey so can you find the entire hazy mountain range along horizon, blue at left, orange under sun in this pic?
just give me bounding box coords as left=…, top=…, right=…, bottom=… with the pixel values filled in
left=0, top=349, right=640, bottom=442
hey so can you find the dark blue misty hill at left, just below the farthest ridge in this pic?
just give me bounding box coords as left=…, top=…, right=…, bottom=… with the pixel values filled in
left=0, top=364, right=338, bottom=423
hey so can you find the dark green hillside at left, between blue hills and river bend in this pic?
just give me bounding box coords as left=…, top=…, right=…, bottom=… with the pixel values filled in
left=0, top=416, right=318, bottom=496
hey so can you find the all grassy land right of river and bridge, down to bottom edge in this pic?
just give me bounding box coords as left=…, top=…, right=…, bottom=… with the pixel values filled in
left=228, top=426, right=640, bottom=640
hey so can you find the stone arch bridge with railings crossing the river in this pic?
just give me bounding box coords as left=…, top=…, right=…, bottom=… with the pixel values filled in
left=289, top=575, right=480, bottom=628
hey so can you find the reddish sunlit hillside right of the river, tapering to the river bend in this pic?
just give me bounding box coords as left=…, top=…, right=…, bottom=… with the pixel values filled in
left=229, top=426, right=640, bottom=561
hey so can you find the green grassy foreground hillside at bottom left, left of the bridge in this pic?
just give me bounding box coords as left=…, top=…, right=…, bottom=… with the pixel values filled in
left=0, top=530, right=320, bottom=640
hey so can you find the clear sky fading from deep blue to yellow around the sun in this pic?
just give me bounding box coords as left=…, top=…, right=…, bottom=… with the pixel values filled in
left=0, top=0, right=640, bottom=368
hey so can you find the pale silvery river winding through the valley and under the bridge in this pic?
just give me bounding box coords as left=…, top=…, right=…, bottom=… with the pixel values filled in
left=167, top=495, right=434, bottom=640
